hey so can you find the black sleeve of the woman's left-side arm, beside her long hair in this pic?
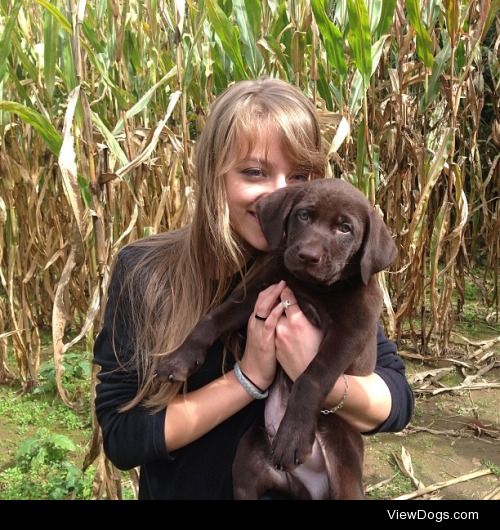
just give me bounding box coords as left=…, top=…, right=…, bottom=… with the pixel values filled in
left=94, top=248, right=169, bottom=469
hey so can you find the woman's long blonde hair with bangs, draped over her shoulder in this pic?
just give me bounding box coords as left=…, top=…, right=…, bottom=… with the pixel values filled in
left=116, top=79, right=325, bottom=410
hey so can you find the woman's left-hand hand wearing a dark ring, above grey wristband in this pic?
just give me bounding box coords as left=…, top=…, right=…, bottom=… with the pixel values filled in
left=241, top=281, right=286, bottom=390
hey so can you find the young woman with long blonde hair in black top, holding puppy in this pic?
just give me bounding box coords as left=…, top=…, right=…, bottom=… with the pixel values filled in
left=94, top=79, right=413, bottom=499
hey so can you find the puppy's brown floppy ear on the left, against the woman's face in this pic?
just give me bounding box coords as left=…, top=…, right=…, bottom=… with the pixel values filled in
left=257, top=184, right=304, bottom=250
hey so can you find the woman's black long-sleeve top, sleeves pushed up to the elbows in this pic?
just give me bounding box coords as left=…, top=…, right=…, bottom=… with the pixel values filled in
left=94, top=248, right=414, bottom=499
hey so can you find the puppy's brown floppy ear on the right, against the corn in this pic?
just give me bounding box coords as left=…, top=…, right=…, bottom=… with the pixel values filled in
left=360, top=208, right=397, bottom=285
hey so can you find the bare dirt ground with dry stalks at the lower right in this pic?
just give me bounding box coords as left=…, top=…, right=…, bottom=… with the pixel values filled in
left=365, top=363, right=500, bottom=499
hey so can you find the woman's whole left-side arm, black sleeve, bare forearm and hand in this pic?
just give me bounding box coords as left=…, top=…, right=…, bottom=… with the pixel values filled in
left=94, top=254, right=284, bottom=469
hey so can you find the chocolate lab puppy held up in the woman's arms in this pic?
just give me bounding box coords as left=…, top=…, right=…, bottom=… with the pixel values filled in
left=158, top=179, right=396, bottom=499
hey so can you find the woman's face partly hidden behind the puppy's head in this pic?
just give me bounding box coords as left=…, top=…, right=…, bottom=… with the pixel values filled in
left=224, top=129, right=309, bottom=251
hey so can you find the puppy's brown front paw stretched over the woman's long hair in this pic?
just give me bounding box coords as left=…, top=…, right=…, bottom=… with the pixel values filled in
left=157, top=341, right=206, bottom=382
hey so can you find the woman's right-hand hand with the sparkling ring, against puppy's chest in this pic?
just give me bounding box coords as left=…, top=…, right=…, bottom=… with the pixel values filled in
left=276, top=287, right=323, bottom=381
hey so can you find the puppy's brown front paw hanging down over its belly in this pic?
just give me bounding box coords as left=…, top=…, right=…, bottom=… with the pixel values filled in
left=272, top=421, right=314, bottom=471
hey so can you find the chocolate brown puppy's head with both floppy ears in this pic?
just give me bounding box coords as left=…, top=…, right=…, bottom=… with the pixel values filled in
left=257, top=179, right=396, bottom=285
